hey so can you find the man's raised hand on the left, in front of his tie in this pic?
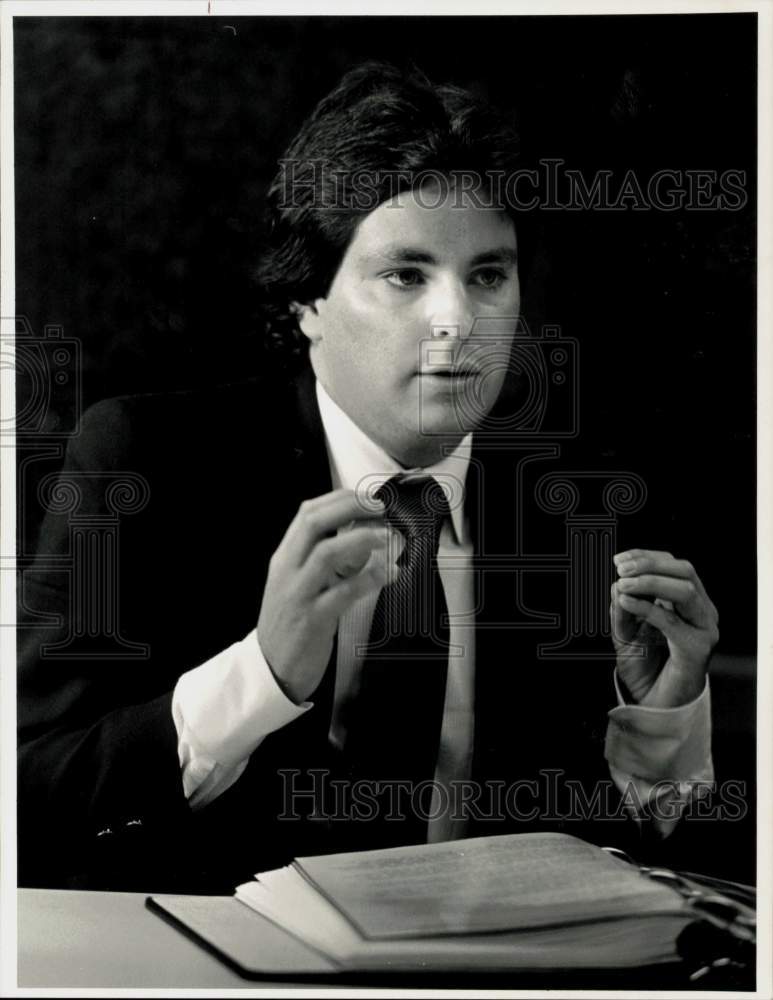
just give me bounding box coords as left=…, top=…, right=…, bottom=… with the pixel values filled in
left=258, top=490, right=402, bottom=703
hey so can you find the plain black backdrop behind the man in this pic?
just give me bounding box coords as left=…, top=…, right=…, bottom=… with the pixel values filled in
left=14, top=14, right=757, bottom=873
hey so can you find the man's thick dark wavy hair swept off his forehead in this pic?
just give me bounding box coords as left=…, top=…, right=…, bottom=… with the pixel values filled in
left=255, top=62, right=528, bottom=374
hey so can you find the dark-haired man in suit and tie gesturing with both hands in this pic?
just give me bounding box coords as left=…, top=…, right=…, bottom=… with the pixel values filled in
left=19, top=66, right=717, bottom=891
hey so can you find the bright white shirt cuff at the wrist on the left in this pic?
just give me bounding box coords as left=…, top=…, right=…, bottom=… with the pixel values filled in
left=172, top=629, right=312, bottom=798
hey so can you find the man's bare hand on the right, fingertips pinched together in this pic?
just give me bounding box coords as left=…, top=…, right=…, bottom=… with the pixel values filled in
left=610, top=549, right=719, bottom=708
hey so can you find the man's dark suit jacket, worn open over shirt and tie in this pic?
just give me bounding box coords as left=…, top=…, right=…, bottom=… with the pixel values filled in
left=19, top=371, right=680, bottom=891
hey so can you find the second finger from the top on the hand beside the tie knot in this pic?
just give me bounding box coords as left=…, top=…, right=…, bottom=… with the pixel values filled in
left=298, top=525, right=402, bottom=597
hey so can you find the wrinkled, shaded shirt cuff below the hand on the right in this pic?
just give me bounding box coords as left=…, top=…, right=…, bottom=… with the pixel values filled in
left=604, top=672, right=714, bottom=783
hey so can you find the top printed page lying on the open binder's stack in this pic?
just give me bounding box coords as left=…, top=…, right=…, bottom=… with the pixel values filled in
left=295, top=833, right=684, bottom=939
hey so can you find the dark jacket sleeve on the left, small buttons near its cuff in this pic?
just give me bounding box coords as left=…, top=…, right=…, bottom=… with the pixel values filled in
left=17, top=400, right=196, bottom=889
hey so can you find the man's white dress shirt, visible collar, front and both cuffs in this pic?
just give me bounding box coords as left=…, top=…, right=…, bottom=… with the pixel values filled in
left=172, top=382, right=713, bottom=841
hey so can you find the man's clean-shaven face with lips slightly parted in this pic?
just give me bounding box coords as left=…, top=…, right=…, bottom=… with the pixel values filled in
left=300, top=186, right=520, bottom=467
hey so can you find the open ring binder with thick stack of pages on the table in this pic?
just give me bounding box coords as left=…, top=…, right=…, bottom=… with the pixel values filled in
left=145, top=833, right=753, bottom=974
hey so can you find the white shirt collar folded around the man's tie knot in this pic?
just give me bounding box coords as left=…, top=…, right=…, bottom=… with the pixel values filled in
left=316, top=379, right=472, bottom=543
